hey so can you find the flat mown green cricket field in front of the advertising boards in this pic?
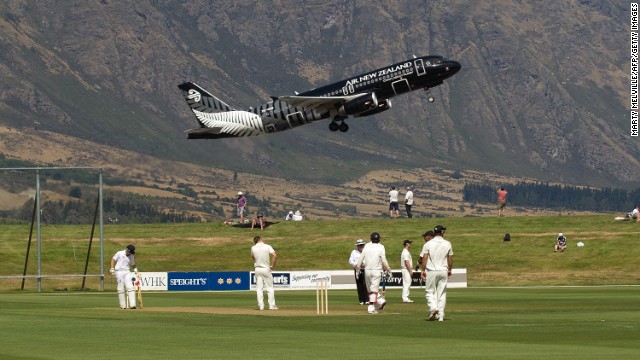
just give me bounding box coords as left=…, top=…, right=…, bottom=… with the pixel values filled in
left=0, top=286, right=640, bottom=359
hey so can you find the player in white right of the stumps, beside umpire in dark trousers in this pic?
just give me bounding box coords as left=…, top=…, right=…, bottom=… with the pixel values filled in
left=356, top=232, right=391, bottom=314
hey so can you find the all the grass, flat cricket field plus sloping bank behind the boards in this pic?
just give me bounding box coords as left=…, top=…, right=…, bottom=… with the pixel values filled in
left=0, top=215, right=640, bottom=359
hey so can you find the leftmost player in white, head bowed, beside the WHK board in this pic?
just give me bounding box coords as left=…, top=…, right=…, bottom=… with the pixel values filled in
left=109, top=245, right=138, bottom=309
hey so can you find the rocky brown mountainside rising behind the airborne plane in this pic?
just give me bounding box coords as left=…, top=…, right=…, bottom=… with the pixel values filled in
left=0, top=0, right=640, bottom=191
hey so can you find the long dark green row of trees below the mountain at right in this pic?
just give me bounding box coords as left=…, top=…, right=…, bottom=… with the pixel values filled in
left=463, top=182, right=640, bottom=212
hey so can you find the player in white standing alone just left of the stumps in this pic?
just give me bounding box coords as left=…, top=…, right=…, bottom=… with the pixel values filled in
left=251, top=236, right=278, bottom=310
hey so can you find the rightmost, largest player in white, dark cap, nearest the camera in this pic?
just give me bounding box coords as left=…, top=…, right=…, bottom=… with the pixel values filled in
left=420, top=225, right=453, bottom=321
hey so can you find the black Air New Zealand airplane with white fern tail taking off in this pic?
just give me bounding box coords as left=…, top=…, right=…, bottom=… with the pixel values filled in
left=178, top=56, right=461, bottom=139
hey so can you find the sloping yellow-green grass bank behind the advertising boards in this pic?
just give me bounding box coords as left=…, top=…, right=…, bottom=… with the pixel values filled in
left=0, top=214, right=640, bottom=291
